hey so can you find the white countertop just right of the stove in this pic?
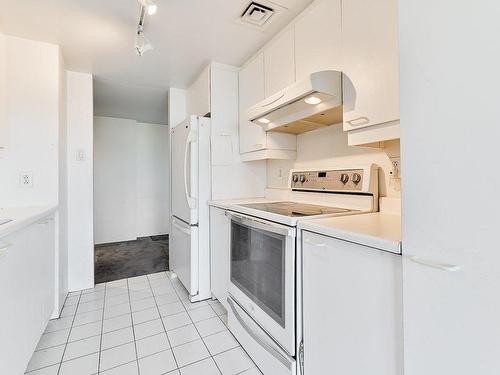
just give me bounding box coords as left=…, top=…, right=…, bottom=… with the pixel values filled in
left=299, top=212, right=401, bottom=254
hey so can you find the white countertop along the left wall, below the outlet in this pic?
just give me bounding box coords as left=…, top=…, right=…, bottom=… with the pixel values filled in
left=0, top=206, right=57, bottom=238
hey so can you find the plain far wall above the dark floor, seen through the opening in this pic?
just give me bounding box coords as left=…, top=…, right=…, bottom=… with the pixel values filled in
left=94, top=117, right=169, bottom=244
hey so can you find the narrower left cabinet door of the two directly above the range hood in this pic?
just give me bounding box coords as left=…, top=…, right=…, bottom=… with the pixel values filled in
left=264, top=27, right=295, bottom=98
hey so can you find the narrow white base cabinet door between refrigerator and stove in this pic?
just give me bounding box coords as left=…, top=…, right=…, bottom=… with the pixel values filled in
left=210, top=207, right=230, bottom=310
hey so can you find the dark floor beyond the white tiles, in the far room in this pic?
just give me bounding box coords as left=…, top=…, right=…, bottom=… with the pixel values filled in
left=94, top=235, right=168, bottom=284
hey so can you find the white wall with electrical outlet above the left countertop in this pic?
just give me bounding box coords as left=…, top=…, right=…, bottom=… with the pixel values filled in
left=0, top=36, right=60, bottom=207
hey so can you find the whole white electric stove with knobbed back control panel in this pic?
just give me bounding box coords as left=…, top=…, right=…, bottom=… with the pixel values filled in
left=227, top=165, right=378, bottom=375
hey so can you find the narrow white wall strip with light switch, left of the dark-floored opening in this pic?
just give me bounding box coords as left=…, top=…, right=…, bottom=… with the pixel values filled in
left=66, top=72, right=94, bottom=291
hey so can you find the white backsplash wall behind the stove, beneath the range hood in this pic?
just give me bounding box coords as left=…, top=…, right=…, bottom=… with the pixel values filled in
left=267, top=124, right=400, bottom=198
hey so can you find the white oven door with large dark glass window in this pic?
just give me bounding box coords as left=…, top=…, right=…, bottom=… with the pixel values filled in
left=228, top=212, right=296, bottom=356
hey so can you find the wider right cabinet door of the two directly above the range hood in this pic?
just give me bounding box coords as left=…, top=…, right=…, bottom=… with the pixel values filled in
left=295, top=0, right=342, bottom=81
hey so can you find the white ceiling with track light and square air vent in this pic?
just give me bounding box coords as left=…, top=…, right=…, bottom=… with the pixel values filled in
left=0, top=0, right=312, bottom=123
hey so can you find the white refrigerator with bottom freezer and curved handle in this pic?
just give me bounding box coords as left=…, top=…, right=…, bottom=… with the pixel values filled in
left=169, top=116, right=211, bottom=302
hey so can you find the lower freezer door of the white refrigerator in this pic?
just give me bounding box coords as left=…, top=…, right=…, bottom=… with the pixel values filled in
left=170, top=217, right=199, bottom=296
